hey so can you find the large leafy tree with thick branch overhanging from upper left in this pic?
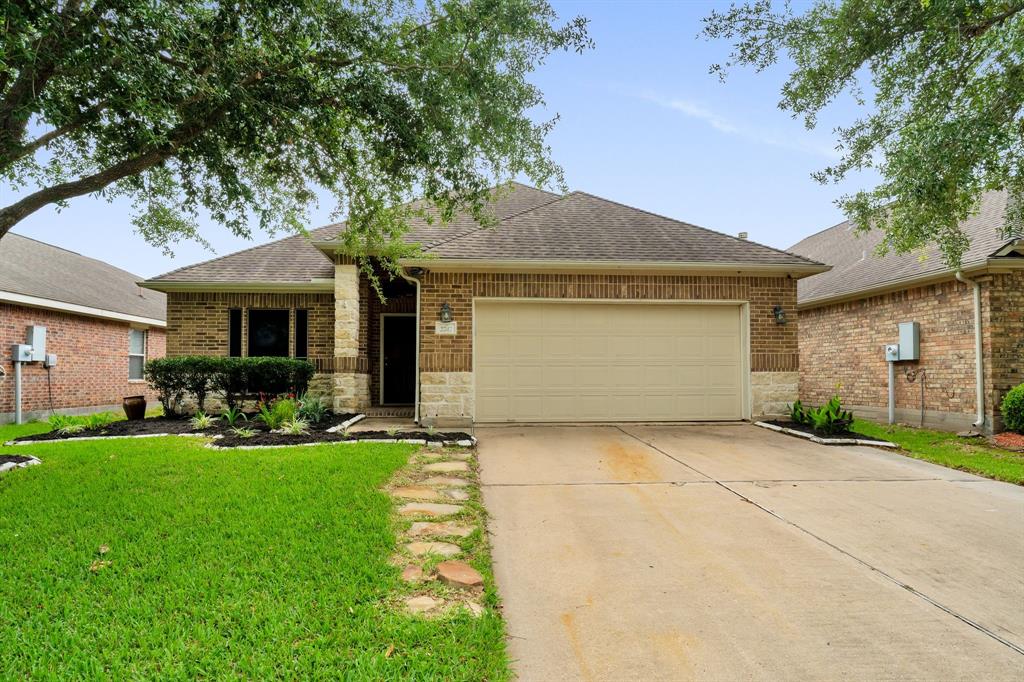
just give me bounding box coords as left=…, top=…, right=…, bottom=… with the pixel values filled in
left=0, top=0, right=590, bottom=256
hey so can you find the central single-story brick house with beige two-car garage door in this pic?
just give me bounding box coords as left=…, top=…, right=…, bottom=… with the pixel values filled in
left=144, top=183, right=826, bottom=424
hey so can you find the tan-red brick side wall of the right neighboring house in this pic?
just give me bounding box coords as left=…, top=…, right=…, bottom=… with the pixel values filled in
left=800, top=273, right=1024, bottom=430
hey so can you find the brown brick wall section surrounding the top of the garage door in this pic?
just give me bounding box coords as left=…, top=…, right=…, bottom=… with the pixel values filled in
left=420, top=272, right=799, bottom=372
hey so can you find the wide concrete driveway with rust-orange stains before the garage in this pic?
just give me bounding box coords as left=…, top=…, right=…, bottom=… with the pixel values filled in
left=477, top=424, right=1024, bottom=680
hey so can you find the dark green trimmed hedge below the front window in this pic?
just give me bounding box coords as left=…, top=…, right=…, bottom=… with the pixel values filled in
left=145, top=355, right=314, bottom=415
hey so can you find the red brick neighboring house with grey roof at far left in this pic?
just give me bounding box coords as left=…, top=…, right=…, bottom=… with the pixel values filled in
left=0, top=232, right=165, bottom=423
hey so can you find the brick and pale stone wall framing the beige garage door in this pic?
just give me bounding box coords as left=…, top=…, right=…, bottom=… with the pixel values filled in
left=420, top=271, right=800, bottom=421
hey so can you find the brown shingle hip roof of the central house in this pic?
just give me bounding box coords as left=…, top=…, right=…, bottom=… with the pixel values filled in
left=146, top=183, right=823, bottom=289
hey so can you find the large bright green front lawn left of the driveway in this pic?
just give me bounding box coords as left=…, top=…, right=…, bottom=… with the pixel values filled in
left=0, top=425, right=508, bottom=680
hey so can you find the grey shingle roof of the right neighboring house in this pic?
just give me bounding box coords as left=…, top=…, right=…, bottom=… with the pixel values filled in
left=790, top=191, right=1015, bottom=305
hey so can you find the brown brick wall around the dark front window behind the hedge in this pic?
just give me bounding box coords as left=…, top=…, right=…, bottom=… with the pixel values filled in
left=167, top=292, right=334, bottom=372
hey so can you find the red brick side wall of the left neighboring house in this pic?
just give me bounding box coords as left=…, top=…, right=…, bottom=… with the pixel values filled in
left=0, top=303, right=165, bottom=421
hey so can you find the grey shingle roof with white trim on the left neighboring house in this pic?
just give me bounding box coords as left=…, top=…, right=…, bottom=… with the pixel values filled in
left=0, top=232, right=167, bottom=324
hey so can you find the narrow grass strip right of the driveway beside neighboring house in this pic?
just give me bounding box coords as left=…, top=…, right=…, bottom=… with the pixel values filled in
left=853, top=419, right=1024, bottom=485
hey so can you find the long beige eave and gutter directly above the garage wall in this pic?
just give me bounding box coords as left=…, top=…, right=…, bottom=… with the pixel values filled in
left=398, top=258, right=831, bottom=279
